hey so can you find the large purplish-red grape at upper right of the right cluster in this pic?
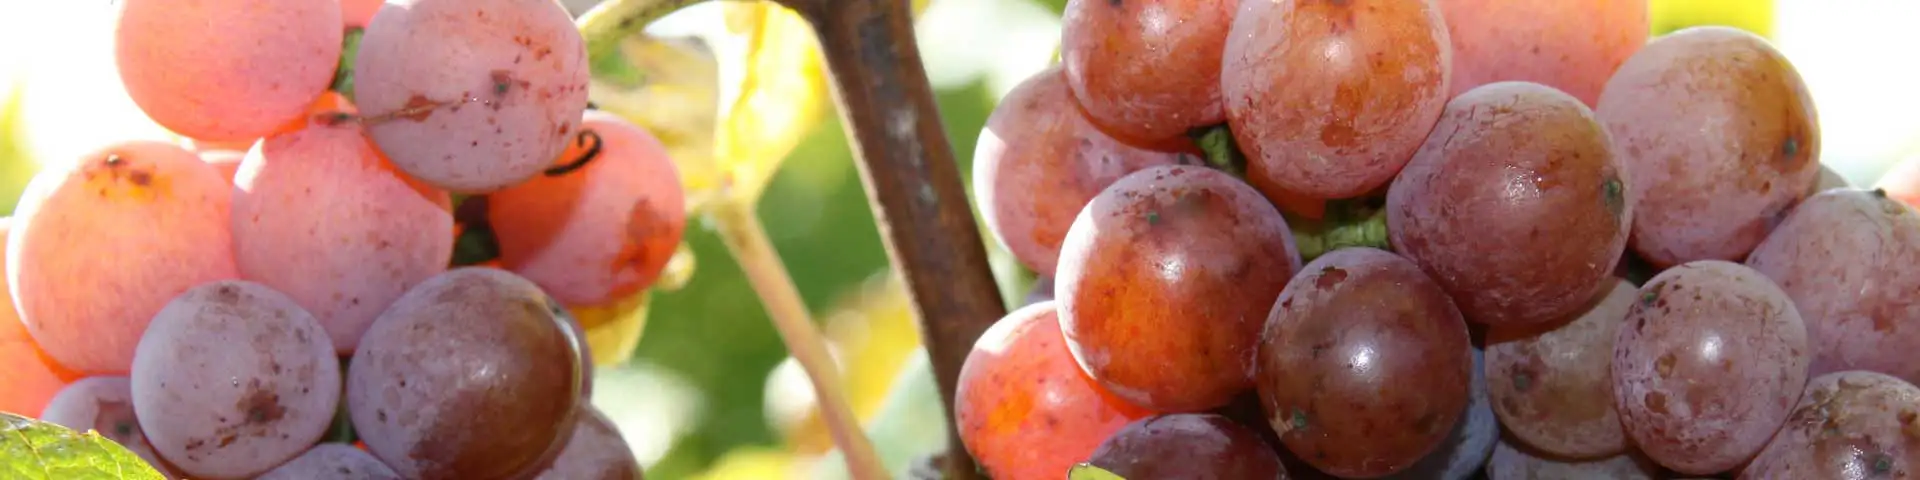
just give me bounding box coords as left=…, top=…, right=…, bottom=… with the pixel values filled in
left=1594, top=27, right=1820, bottom=267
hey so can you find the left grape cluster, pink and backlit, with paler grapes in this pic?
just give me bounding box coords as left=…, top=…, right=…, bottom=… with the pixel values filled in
left=0, top=0, right=687, bottom=480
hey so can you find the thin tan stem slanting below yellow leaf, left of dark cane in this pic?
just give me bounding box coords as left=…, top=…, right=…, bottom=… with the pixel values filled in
left=708, top=196, right=889, bottom=480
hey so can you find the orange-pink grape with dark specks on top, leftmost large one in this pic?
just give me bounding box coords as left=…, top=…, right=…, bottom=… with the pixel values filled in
left=6, top=140, right=240, bottom=374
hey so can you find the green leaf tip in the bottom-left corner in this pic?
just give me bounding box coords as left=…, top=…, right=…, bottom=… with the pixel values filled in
left=0, top=413, right=165, bottom=480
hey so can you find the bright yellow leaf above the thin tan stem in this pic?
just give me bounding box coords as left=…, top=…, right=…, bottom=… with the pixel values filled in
left=714, top=2, right=828, bottom=202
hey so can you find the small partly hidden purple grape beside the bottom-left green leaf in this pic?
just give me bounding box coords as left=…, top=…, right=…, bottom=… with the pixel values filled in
left=40, top=376, right=179, bottom=478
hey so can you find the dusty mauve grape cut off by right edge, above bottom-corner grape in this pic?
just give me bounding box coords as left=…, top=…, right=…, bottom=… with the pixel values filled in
left=1747, top=188, right=1920, bottom=382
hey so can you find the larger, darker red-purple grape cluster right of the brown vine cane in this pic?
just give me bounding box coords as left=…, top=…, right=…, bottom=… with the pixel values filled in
left=954, top=0, right=1920, bottom=480
